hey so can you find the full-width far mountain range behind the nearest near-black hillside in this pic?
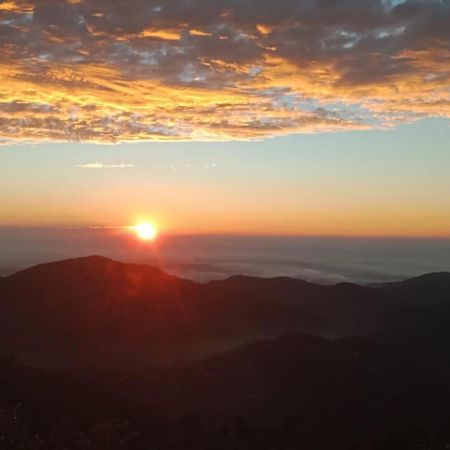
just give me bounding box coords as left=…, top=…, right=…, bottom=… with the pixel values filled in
left=0, top=256, right=447, bottom=369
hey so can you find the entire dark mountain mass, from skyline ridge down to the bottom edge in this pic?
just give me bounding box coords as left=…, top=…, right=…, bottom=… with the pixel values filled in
left=0, top=256, right=450, bottom=450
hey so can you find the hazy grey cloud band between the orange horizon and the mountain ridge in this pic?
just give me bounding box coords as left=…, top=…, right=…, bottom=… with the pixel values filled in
left=0, top=228, right=450, bottom=284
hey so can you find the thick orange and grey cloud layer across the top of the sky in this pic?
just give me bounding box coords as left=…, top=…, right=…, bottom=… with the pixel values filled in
left=0, top=0, right=450, bottom=143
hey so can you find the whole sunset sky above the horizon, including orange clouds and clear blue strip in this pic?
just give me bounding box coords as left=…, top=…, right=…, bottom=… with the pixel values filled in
left=0, top=0, right=450, bottom=237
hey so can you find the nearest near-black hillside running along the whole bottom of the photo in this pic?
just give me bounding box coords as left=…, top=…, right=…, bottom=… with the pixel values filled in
left=0, top=333, right=450, bottom=450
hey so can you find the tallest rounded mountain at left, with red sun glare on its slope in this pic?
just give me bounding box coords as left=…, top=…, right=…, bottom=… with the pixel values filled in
left=0, top=256, right=321, bottom=367
